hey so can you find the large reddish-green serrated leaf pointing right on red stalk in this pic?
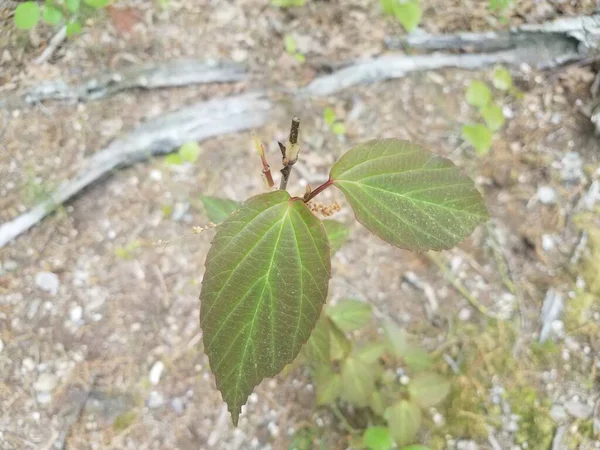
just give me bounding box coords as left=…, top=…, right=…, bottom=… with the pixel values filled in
left=330, top=139, right=488, bottom=251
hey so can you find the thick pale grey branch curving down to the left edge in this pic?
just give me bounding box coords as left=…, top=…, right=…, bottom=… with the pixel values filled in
left=0, top=93, right=271, bottom=248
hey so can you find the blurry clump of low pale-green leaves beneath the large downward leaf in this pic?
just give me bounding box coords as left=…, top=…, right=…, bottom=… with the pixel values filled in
left=301, top=299, right=450, bottom=450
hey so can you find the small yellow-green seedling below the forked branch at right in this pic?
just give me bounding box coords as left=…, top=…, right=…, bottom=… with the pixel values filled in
left=462, top=67, right=515, bottom=156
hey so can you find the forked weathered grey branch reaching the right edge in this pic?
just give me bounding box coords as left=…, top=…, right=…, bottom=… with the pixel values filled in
left=303, top=16, right=600, bottom=96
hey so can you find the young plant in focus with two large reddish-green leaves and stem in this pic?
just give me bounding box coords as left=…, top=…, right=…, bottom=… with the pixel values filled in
left=200, top=119, right=488, bottom=425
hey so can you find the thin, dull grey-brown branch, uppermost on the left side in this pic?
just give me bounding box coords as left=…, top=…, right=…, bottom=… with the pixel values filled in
left=0, top=60, right=246, bottom=109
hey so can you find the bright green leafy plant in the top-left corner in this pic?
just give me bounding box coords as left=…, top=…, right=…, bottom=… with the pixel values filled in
left=14, top=0, right=112, bottom=37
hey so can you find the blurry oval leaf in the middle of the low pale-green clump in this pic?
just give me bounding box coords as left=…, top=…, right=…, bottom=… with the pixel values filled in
left=340, top=356, right=375, bottom=408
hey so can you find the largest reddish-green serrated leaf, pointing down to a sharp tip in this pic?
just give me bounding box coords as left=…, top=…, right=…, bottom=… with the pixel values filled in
left=200, top=190, right=331, bottom=425
